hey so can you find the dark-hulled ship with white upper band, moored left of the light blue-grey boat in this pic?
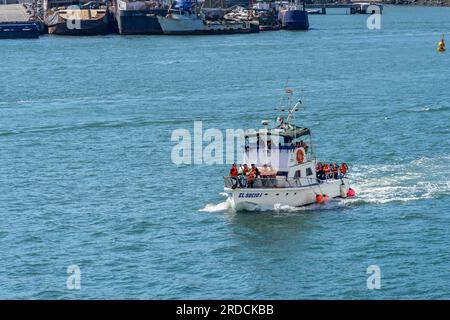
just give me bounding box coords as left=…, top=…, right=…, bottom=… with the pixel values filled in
left=114, top=0, right=168, bottom=35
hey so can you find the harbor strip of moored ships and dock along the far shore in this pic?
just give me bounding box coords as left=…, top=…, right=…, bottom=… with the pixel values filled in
left=0, top=0, right=384, bottom=38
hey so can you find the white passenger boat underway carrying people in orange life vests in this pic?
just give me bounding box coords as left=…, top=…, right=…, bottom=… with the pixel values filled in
left=224, top=89, right=355, bottom=211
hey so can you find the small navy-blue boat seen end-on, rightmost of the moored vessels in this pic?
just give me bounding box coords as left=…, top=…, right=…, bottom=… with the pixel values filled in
left=279, top=0, right=309, bottom=30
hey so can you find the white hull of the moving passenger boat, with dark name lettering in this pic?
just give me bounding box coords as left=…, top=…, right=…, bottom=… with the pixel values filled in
left=225, top=179, right=349, bottom=211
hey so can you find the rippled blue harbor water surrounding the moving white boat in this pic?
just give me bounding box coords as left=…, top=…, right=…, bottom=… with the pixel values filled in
left=0, top=7, right=450, bottom=299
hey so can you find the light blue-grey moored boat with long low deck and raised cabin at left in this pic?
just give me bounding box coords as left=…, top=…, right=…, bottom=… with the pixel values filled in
left=158, top=0, right=259, bottom=35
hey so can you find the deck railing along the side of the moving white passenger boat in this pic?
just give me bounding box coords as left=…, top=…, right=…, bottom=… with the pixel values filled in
left=223, top=176, right=324, bottom=189
